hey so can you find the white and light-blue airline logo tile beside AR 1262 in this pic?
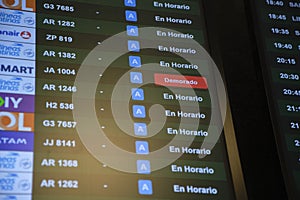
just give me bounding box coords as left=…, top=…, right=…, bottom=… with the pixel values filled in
left=0, top=172, right=32, bottom=194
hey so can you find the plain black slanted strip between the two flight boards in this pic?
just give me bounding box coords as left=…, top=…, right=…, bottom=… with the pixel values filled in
left=204, top=0, right=287, bottom=199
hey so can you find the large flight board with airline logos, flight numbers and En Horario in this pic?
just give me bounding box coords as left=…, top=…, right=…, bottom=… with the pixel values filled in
left=0, top=0, right=245, bottom=200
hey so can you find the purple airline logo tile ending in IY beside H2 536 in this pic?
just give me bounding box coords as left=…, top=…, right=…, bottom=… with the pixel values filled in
left=0, top=93, right=34, bottom=112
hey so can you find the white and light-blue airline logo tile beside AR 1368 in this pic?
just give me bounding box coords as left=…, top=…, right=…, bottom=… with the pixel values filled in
left=0, top=151, right=33, bottom=172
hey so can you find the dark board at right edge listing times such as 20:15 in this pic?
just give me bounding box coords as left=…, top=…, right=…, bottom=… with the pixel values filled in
left=254, top=0, right=300, bottom=199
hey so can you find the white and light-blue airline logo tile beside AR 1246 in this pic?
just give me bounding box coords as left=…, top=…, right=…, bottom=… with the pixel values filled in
left=0, top=75, right=35, bottom=95
